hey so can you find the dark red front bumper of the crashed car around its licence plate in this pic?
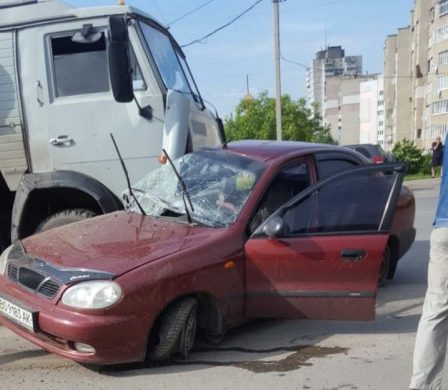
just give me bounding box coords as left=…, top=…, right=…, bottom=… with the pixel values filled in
left=0, top=277, right=149, bottom=364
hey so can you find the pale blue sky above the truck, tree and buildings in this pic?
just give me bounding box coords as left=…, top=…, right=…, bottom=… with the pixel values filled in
left=65, top=0, right=413, bottom=118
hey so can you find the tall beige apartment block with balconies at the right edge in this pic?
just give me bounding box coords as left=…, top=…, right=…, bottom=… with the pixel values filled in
left=384, top=0, right=448, bottom=150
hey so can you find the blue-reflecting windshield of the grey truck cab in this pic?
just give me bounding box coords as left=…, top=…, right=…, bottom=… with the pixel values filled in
left=140, top=21, right=196, bottom=97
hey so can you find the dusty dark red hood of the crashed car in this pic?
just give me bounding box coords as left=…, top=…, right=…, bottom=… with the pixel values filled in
left=23, top=211, right=223, bottom=276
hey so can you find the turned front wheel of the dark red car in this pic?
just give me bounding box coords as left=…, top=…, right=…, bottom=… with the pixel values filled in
left=149, top=297, right=197, bottom=361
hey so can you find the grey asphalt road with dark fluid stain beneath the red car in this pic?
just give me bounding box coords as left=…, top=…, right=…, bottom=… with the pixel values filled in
left=0, top=180, right=440, bottom=390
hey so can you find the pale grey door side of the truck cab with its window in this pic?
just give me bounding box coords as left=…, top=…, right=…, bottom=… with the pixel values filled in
left=19, top=19, right=164, bottom=195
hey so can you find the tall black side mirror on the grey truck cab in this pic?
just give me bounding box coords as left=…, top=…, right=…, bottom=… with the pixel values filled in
left=107, top=15, right=134, bottom=103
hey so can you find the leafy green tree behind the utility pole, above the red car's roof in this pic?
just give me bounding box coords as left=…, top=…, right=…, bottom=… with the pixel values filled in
left=225, top=91, right=334, bottom=143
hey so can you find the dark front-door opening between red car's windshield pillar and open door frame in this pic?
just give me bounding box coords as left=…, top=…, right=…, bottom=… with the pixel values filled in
left=249, top=162, right=311, bottom=232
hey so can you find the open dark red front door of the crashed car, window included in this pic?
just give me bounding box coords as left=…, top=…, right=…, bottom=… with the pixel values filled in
left=245, top=163, right=405, bottom=320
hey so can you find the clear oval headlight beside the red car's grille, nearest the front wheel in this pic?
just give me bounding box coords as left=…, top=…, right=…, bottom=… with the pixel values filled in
left=62, top=280, right=123, bottom=309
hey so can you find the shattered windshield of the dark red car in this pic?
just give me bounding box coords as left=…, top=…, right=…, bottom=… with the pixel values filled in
left=123, top=149, right=264, bottom=227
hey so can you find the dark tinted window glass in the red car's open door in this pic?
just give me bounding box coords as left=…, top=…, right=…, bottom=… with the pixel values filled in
left=266, top=167, right=401, bottom=236
